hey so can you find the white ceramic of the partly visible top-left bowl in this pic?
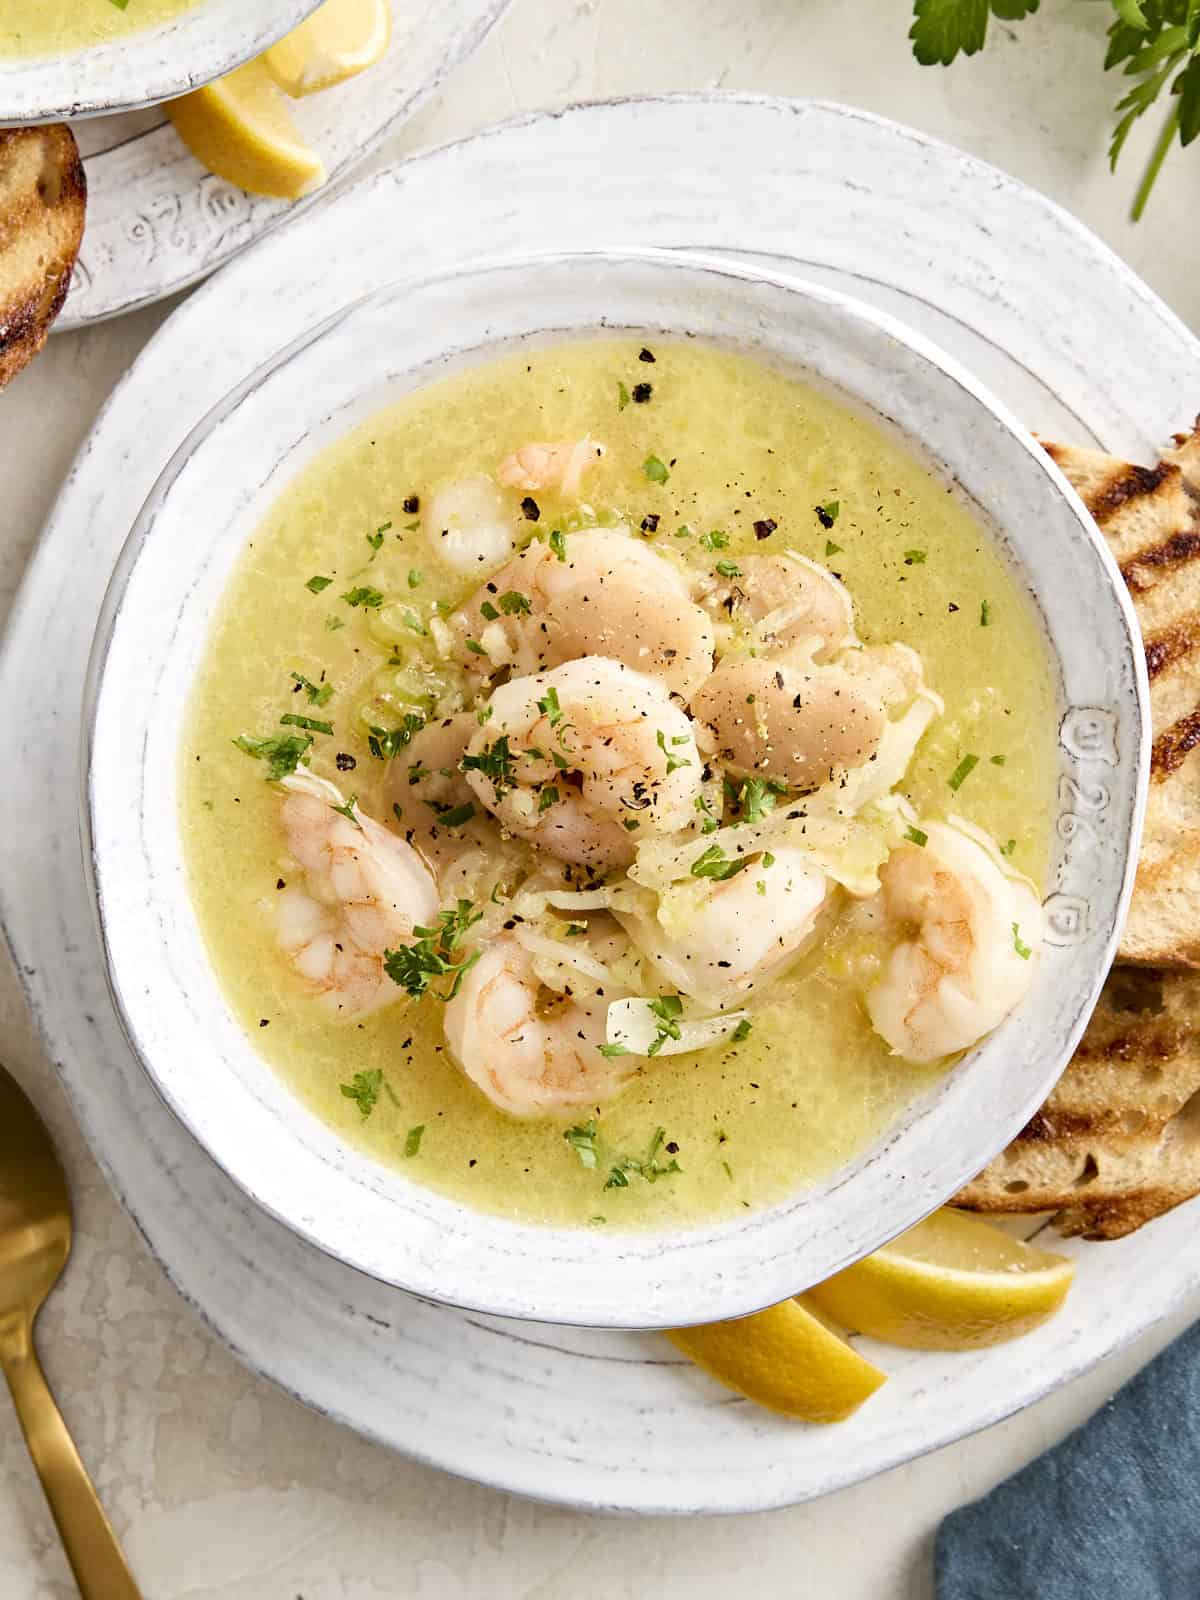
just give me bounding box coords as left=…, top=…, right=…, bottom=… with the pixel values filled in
left=0, top=0, right=320, bottom=126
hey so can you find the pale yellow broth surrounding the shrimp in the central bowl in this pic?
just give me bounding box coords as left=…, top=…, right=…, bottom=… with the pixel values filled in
left=181, top=339, right=1054, bottom=1227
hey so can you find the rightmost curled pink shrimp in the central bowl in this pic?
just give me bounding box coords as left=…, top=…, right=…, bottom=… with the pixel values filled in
left=867, top=822, right=1042, bottom=1062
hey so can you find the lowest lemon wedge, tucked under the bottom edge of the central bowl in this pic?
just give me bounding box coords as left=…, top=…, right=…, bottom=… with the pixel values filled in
left=667, top=1299, right=886, bottom=1422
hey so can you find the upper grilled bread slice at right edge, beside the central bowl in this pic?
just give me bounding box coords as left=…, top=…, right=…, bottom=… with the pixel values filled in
left=1046, top=419, right=1200, bottom=968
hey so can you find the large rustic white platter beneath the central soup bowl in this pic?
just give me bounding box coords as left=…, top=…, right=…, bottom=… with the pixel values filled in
left=0, top=96, right=1200, bottom=1514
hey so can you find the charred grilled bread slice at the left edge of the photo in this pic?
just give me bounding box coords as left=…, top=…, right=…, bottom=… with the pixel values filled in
left=0, top=123, right=86, bottom=389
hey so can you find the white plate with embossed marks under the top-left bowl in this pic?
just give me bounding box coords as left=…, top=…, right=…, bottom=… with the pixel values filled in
left=61, top=0, right=509, bottom=331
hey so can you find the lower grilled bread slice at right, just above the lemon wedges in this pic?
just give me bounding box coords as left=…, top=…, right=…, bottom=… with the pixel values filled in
left=954, top=966, right=1200, bottom=1238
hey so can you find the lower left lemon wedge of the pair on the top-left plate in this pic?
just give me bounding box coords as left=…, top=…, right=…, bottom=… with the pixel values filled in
left=166, top=58, right=325, bottom=200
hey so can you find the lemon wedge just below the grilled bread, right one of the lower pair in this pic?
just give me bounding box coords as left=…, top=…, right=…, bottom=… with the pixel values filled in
left=808, top=1211, right=1075, bottom=1350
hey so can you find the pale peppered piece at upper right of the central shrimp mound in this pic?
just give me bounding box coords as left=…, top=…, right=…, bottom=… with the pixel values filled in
left=709, top=550, right=854, bottom=661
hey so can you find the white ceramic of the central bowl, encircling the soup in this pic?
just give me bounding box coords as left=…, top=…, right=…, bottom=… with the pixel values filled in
left=83, top=251, right=1149, bottom=1328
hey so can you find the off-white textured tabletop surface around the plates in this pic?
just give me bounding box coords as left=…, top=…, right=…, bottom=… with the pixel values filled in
left=0, top=0, right=1200, bottom=1600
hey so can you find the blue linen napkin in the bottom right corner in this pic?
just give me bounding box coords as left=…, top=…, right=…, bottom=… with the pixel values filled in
left=934, top=1323, right=1200, bottom=1600
